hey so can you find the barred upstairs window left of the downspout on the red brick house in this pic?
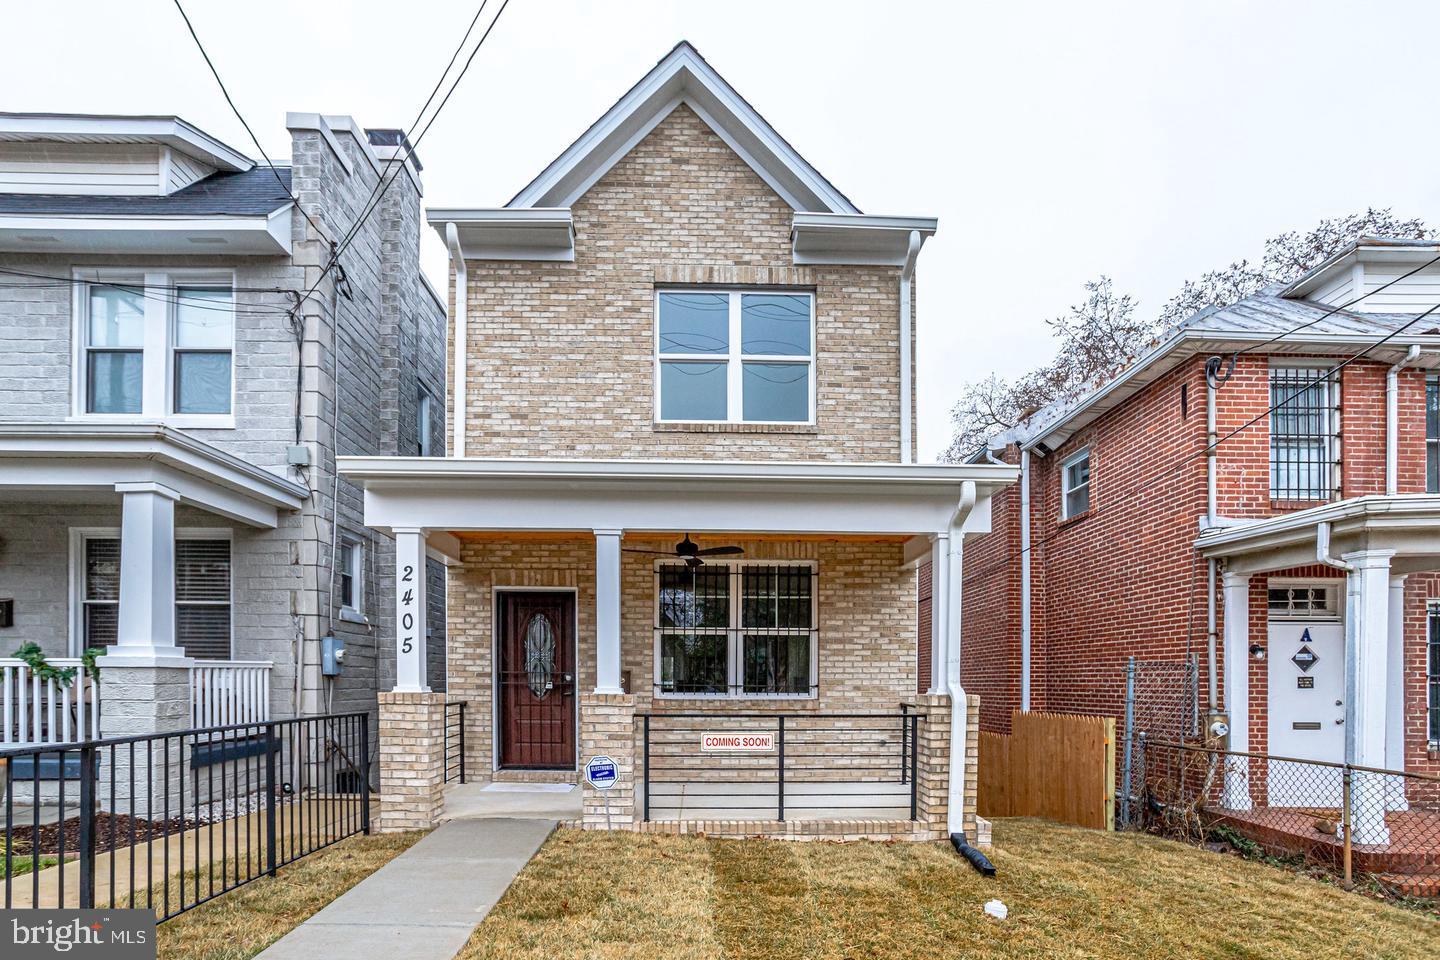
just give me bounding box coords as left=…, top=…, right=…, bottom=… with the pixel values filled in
left=1270, top=367, right=1335, bottom=501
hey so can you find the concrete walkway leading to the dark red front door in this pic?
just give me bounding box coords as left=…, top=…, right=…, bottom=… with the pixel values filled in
left=259, top=819, right=556, bottom=960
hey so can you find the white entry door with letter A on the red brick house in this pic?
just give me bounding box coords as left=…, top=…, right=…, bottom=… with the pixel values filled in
left=1266, top=620, right=1345, bottom=807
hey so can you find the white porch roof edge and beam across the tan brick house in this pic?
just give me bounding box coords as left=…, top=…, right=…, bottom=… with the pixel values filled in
left=340, top=458, right=1017, bottom=535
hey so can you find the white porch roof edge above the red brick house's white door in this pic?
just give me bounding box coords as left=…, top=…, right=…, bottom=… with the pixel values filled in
left=1195, top=494, right=1440, bottom=573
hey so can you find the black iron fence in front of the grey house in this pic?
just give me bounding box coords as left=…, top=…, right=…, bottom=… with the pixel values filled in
left=0, top=714, right=370, bottom=921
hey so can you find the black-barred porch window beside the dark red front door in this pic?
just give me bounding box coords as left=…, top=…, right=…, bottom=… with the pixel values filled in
left=655, top=563, right=818, bottom=697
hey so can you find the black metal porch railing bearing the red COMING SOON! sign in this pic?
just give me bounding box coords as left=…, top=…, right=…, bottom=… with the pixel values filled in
left=636, top=710, right=922, bottom=822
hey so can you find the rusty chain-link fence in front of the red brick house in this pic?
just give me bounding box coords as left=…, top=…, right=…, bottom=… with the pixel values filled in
left=1135, top=735, right=1440, bottom=900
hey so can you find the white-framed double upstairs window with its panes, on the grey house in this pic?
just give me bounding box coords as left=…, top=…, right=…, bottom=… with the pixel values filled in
left=75, top=271, right=235, bottom=426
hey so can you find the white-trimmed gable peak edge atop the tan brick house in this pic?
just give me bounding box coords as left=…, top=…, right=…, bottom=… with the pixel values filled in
left=505, top=40, right=860, bottom=213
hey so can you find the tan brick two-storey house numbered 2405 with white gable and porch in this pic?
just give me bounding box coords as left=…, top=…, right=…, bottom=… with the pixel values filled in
left=341, top=43, right=1015, bottom=836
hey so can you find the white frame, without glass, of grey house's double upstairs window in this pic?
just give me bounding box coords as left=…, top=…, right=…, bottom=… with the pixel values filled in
left=69, top=268, right=239, bottom=429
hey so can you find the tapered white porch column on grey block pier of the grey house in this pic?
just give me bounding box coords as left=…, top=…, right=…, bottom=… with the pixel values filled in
left=107, top=482, right=184, bottom=666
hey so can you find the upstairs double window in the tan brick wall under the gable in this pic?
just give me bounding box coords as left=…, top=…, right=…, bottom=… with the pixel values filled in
left=655, top=291, right=815, bottom=423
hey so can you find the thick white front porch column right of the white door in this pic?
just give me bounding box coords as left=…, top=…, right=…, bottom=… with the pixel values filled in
left=1341, top=550, right=1395, bottom=843
